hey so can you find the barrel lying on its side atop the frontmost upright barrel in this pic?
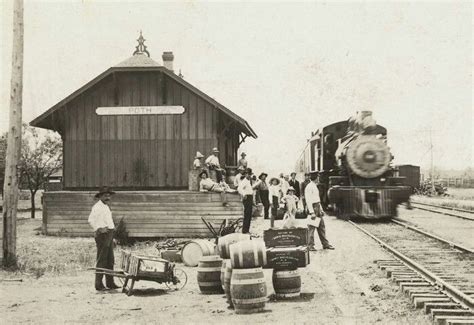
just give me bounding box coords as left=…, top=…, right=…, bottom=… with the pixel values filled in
left=230, top=240, right=267, bottom=269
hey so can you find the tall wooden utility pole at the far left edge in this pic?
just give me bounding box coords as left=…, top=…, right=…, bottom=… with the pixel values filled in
left=3, top=0, right=24, bottom=266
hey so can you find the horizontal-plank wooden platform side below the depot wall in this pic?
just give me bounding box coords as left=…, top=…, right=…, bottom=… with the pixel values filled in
left=43, top=191, right=243, bottom=237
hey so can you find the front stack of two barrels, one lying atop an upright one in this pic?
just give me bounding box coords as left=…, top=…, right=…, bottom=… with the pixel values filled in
left=229, top=240, right=267, bottom=314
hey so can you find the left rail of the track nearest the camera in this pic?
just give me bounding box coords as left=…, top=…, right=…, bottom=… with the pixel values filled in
left=348, top=221, right=474, bottom=310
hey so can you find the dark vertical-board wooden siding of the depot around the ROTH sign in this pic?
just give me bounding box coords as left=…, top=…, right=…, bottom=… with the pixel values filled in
left=61, top=71, right=225, bottom=189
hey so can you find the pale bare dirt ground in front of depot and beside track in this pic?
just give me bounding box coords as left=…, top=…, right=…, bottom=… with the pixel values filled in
left=0, top=217, right=430, bottom=324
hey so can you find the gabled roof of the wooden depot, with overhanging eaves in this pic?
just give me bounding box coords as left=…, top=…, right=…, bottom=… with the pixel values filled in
left=30, top=53, right=257, bottom=138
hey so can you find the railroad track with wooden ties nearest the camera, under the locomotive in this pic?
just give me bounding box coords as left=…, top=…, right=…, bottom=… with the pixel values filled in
left=349, top=220, right=474, bottom=324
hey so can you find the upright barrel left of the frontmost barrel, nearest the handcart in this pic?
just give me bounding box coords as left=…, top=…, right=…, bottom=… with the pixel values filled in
left=197, top=255, right=224, bottom=294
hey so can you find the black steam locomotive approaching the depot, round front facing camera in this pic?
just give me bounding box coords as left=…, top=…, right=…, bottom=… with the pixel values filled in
left=296, top=111, right=411, bottom=220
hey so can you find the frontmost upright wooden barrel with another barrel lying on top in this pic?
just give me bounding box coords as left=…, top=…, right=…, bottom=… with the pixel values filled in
left=230, top=267, right=267, bottom=314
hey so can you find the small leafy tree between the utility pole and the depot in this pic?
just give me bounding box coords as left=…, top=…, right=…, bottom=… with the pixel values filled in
left=19, top=124, right=63, bottom=218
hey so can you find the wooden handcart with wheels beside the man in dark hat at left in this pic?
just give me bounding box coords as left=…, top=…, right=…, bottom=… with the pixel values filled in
left=90, top=251, right=188, bottom=296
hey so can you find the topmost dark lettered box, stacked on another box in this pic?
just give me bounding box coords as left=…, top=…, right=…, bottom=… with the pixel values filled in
left=263, top=228, right=308, bottom=247
